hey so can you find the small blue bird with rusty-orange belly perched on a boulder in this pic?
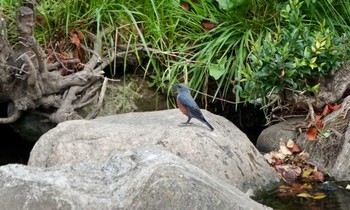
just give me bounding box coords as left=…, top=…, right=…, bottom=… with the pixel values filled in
left=174, top=84, right=214, bottom=131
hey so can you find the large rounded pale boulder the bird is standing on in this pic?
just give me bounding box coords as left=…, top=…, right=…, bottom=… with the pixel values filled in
left=28, top=109, right=279, bottom=192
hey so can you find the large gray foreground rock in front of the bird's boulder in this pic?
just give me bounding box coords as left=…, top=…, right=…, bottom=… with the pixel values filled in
left=0, top=147, right=271, bottom=210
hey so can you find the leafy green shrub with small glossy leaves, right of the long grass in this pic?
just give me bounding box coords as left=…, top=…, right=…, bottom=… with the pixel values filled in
left=242, top=0, right=346, bottom=104
